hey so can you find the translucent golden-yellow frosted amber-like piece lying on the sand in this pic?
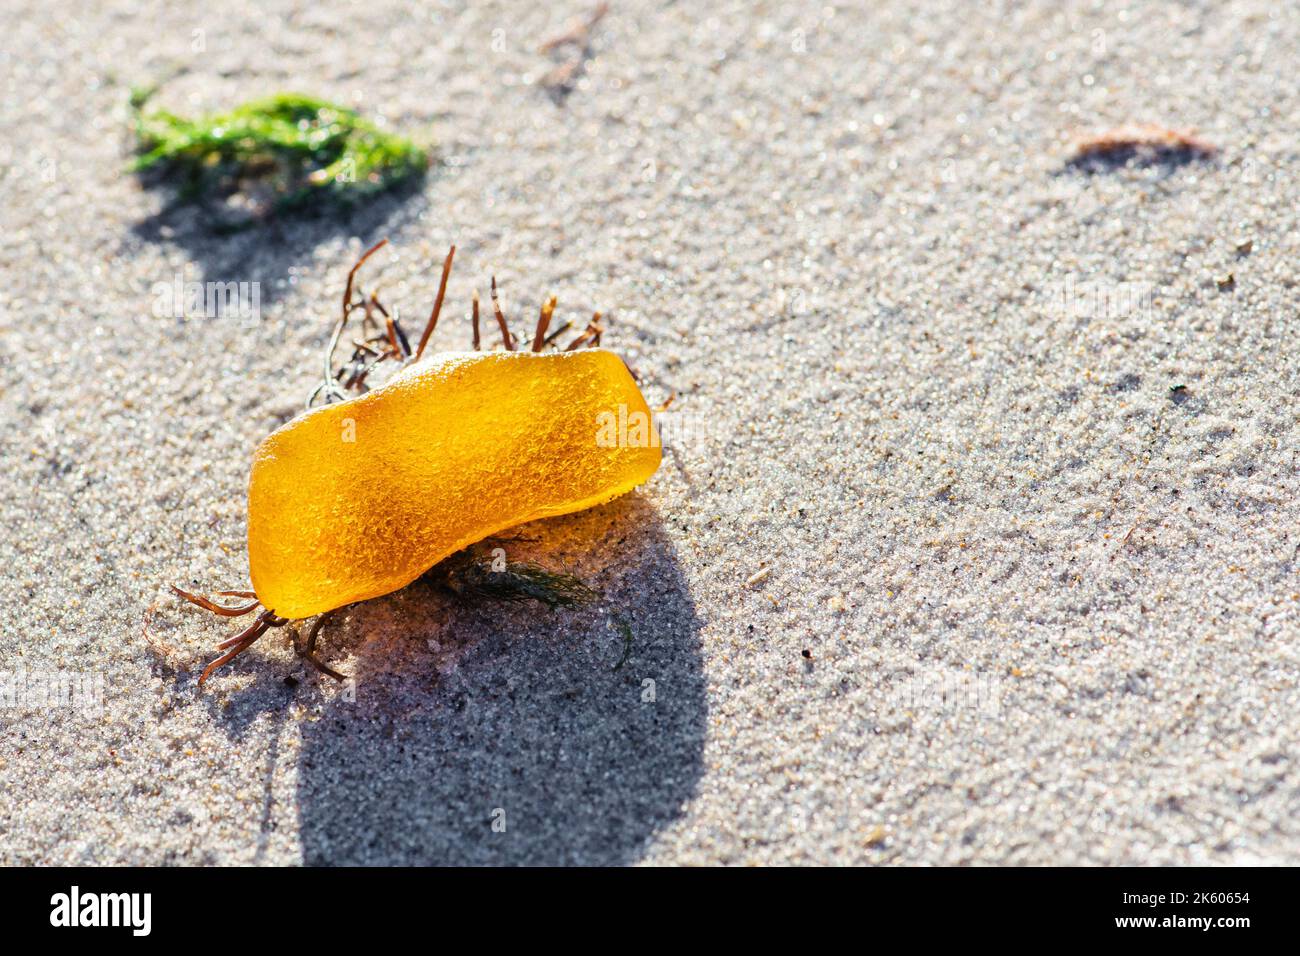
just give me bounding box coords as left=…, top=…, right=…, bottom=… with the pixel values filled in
left=248, top=349, right=662, bottom=618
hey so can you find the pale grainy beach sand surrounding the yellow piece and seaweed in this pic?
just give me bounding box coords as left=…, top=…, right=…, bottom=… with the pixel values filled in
left=0, top=0, right=1300, bottom=865
